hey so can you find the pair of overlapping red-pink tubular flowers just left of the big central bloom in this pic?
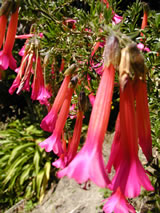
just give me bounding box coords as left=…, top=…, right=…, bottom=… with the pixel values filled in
left=39, top=64, right=78, bottom=156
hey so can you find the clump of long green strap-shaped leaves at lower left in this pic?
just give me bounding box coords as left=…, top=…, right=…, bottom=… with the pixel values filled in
left=0, top=120, right=53, bottom=209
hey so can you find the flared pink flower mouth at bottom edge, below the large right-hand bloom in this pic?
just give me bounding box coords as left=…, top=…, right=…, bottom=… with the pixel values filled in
left=103, top=188, right=136, bottom=213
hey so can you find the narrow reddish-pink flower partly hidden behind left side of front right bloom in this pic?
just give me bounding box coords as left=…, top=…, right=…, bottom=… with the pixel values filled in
left=106, top=113, right=121, bottom=173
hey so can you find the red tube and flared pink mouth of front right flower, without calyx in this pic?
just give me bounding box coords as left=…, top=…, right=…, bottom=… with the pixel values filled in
left=111, top=79, right=153, bottom=198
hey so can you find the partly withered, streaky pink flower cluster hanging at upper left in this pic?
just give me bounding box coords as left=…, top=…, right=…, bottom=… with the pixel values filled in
left=9, top=34, right=51, bottom=106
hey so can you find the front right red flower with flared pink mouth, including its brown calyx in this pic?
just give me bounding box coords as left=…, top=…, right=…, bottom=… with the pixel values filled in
left=111, top=45, right=153, bottom=198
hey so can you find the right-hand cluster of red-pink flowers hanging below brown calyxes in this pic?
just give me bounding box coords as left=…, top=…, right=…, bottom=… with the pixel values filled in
left=104, top=44, right=153, bottom=212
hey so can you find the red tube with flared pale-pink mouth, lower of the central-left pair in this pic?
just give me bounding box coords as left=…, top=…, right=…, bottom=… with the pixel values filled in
left=39, top=85, right=74, bottom=156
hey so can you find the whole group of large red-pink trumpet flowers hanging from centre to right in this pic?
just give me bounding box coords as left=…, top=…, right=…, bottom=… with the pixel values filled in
left=40, top=36, right=153, bottom=213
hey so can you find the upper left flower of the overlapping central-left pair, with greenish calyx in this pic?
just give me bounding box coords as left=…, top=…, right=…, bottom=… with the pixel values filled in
left=40, top=64, right=77, bottom=132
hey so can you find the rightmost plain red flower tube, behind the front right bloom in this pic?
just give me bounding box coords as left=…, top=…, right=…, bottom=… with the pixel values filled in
left=135, top=79, right=152, bottom=161
